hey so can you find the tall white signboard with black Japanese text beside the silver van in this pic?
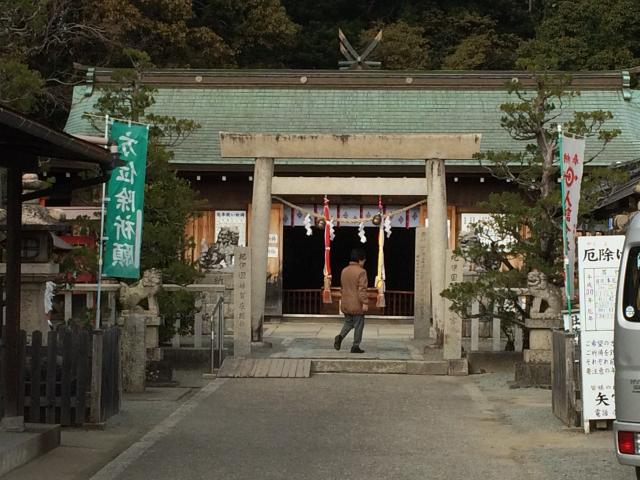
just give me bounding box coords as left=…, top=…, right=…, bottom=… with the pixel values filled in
left=577, top=235, right=624, bottom=431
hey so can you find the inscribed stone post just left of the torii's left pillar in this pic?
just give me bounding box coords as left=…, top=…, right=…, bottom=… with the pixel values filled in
left=233, top=247, right=252, bottom=358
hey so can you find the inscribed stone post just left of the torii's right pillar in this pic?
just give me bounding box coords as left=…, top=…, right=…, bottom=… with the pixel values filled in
left=413, top=227, right=431, bottom=340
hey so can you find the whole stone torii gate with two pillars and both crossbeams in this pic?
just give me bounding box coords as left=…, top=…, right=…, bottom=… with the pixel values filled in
left=220, top=132, right=482, bottom=359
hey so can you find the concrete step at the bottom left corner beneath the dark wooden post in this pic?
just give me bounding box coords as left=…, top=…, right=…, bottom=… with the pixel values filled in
left=0, top=423, right=60, bottom=476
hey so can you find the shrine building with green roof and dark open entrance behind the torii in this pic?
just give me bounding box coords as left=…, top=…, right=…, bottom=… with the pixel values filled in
left=66, top=68, right=640, bottom=318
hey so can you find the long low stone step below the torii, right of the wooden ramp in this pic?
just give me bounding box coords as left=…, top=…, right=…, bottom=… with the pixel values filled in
left=311, top=358, right=469, bottom=375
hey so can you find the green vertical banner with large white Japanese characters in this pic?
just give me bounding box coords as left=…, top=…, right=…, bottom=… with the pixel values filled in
left=102, top=121, right=149, bottom=278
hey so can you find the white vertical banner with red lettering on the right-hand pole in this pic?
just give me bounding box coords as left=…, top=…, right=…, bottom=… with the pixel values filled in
left=560, top=136, right=585, bottom=297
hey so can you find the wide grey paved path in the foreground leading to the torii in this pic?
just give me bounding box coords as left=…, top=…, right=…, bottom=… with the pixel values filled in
left=86, top=375, right=633, bottom=480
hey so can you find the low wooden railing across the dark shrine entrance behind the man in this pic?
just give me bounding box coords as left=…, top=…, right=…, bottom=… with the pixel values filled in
left=282, top=288, right=413, bottom=317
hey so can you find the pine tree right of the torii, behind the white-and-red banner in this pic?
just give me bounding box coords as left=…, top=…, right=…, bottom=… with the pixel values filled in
left=442, top=76, right=626, bottom=338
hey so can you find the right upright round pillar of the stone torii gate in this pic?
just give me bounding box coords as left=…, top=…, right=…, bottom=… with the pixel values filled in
left=425, top=159, right=448, bottom=345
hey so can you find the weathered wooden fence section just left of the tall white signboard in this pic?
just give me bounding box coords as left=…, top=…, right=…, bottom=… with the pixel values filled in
left=551, top=330, right=581, bottom=427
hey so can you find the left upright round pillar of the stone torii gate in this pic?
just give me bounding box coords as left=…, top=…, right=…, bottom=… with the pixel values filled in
left=251, top=157, right=274, bottom=342
